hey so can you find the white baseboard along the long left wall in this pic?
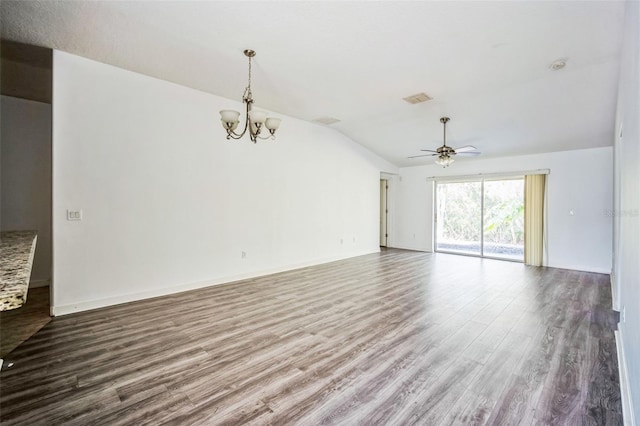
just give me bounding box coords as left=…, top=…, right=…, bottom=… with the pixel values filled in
left=51, top=248, right=380, bottom=316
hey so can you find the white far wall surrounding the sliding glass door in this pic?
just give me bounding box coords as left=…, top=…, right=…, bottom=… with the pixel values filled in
left=394, top=148, right=613, bottom=273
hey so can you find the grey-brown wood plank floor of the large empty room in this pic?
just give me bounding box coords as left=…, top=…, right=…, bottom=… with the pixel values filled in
left=0, top=250, right=622, bottom=425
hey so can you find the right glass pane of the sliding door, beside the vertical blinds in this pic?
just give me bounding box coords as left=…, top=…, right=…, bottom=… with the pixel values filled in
left=484, top=179, right=524, bottom=260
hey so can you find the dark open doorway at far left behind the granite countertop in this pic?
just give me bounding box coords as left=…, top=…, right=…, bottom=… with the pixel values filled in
left=0, top=40, right=53, bottom=358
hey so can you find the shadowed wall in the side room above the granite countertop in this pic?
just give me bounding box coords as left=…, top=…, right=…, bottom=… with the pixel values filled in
left=0, top=96, right=51, bottom=287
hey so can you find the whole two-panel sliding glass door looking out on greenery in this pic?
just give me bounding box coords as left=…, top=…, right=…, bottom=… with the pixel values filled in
left=435, top=177, right=524, bottom=261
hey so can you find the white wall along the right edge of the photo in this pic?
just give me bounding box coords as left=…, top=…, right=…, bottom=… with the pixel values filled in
left=612, top=1, right=640, bottom=424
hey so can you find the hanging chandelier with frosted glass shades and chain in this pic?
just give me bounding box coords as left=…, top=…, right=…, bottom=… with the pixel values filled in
left=220, top=49, right=280, bottom=143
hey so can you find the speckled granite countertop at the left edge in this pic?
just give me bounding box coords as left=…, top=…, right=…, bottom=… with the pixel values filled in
left=0, top=231, right=37, bottom=311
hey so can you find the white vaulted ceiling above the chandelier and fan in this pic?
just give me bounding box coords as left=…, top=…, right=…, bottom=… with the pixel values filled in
left=0, top=0, right=624, bottom=166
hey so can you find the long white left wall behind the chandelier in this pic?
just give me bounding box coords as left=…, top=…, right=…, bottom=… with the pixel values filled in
left=53, top=51, right=396, bottom=314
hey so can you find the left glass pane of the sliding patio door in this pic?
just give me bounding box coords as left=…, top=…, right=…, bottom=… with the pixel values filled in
left=436, top=182, right=482, bottom=255
